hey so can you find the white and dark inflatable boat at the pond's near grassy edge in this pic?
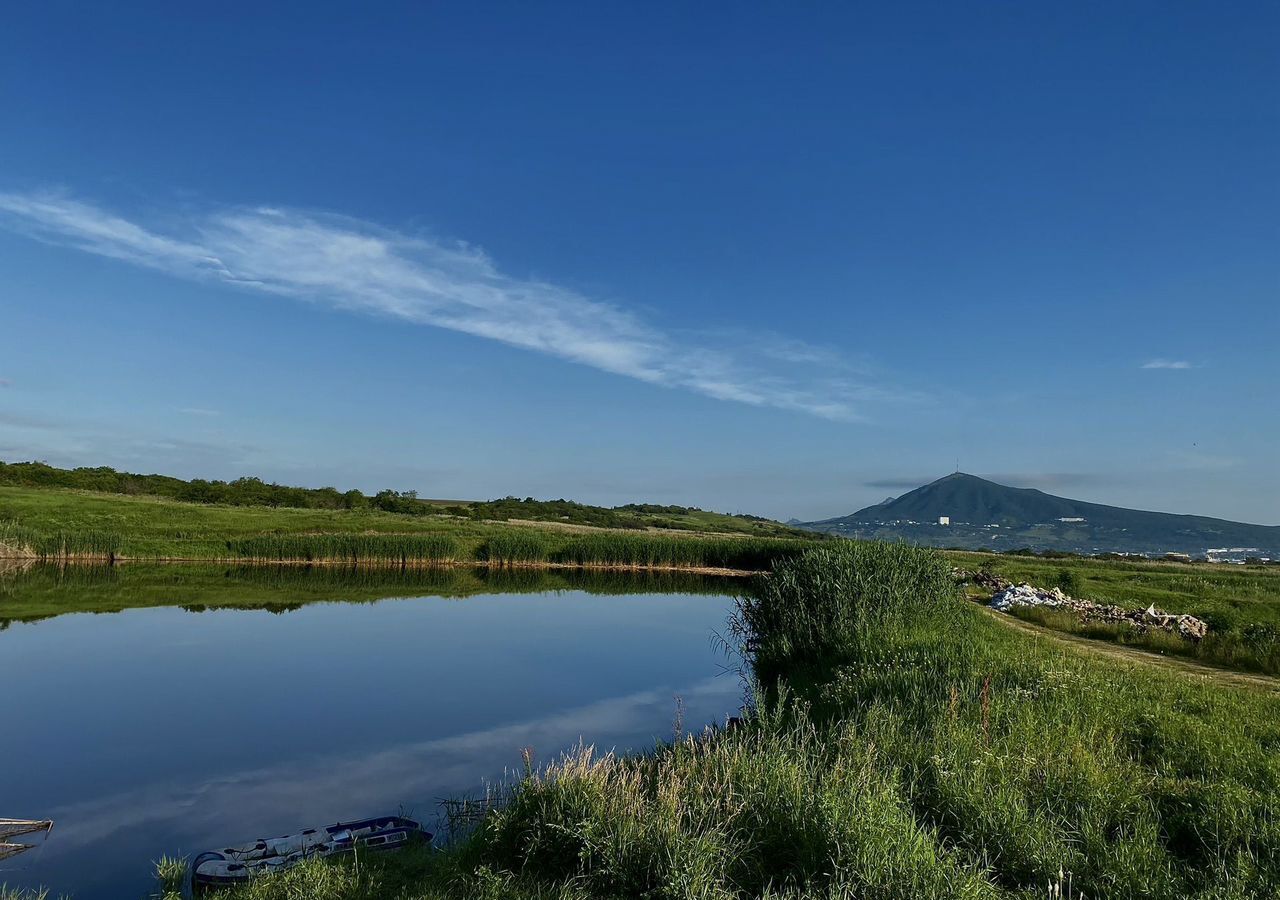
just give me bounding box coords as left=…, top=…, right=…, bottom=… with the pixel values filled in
left=191, top=816, right=431, bottom=885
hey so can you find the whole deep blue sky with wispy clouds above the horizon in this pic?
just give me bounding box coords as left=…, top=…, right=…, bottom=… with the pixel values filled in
left=0, top=3, right=1280, bottom=524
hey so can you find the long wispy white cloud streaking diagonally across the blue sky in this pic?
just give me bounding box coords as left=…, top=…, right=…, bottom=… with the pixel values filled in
left=0, top=192, right=911, bottom=420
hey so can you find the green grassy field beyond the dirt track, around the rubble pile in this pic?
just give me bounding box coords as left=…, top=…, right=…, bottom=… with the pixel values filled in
left=948, top=553, right=1280, bottom=675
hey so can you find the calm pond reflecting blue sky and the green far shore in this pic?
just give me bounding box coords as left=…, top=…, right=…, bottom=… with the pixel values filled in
left=0, top=566, right=742, bottom=900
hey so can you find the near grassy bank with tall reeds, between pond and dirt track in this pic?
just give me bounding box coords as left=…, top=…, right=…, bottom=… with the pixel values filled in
left=137, top=544, right=1280, bottom=900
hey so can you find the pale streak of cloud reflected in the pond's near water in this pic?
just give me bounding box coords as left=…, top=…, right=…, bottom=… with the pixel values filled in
left=27, top=677, right=741, bottom=897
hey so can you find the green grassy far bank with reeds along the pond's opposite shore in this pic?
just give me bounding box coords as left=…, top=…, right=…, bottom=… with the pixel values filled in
left=0, top=488, right=812, bottom=570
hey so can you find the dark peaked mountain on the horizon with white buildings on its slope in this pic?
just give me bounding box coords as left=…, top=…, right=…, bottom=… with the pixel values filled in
left=800, top=472, right=1280, bottom=558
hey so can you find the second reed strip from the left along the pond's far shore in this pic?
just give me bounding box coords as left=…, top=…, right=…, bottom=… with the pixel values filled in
left=227, top=534, right=460, bottom=565
